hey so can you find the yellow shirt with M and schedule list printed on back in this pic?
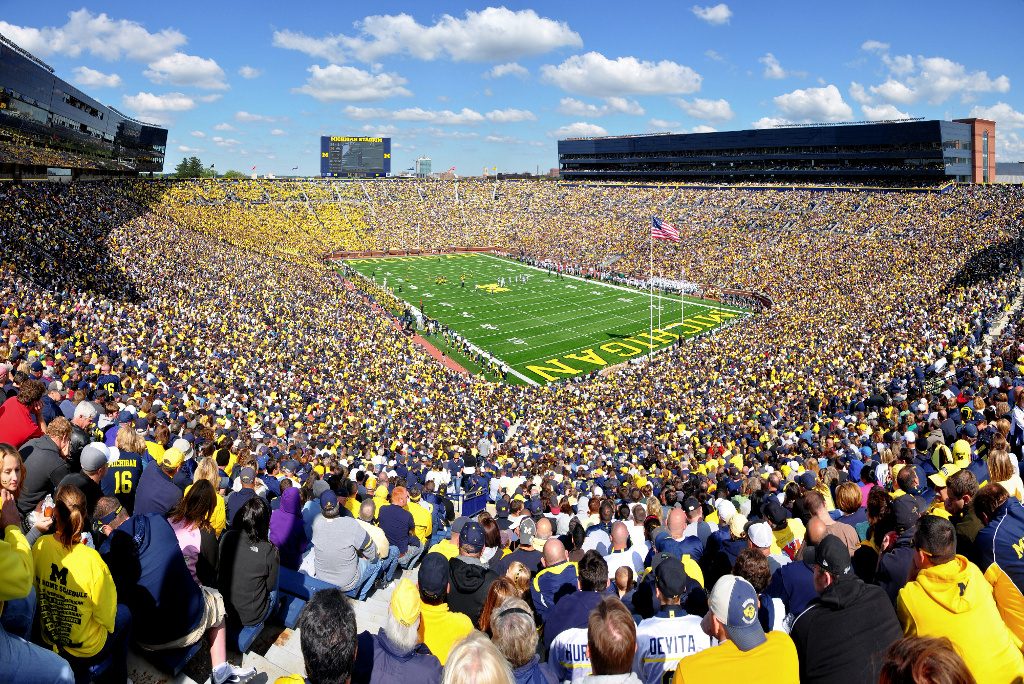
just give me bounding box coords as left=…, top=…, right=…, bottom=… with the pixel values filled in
left=32, top=535, right=118, bottom=657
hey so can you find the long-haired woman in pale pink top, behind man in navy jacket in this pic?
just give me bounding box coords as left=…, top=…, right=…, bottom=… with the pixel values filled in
left=167, top=479, right=218, bottom=587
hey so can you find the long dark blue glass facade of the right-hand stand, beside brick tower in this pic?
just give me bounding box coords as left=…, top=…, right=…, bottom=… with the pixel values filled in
left=558, top=121, right=972, bottom=183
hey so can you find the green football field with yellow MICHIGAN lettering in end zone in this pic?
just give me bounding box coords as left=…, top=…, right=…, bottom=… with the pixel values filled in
left=345, top=254, right=749, bottom=384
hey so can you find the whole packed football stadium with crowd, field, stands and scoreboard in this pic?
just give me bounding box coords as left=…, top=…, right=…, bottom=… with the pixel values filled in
left=6, top=5, right=1024, bottom=684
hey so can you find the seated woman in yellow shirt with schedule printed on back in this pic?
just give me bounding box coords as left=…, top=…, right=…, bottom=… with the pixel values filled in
left=32, top=484, right=131, bottom=682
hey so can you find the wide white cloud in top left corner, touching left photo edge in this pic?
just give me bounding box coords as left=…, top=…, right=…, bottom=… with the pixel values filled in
left=0, top=9, right=186, bottom=61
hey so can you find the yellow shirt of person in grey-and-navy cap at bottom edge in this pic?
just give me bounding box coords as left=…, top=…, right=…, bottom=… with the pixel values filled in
left=672, top=632, right=800, bottom=684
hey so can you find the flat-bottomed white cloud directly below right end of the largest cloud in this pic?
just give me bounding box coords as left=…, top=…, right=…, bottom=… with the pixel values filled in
left=541, top=52, right=701, bottom=97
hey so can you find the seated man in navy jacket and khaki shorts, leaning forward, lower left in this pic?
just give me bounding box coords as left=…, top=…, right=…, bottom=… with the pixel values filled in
left=95, top=497, right=255, bottom=684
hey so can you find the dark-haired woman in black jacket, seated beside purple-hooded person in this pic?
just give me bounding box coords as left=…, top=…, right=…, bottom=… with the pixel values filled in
left=217, top=497, right=281, bottom=641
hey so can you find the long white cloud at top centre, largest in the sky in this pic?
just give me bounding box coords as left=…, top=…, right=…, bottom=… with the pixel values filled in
left=273, top=7, right=583, bottom=62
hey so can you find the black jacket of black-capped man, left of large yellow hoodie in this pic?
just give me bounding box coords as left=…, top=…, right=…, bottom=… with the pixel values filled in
left=790, top=574, right=903, bottom=684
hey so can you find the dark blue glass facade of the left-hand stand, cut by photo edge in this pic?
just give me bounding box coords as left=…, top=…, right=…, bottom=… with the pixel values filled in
left=0, top=36, right=167, bottom=172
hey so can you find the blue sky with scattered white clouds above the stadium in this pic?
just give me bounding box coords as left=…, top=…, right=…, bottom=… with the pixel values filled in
left=0, top=0, right=1024, bottom=175
